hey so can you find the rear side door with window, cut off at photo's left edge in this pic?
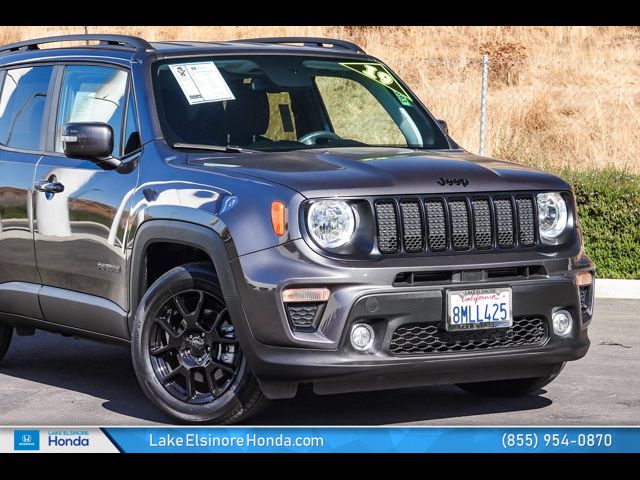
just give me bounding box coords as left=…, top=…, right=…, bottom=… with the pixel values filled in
left=0, top=65, right=54, bottom=318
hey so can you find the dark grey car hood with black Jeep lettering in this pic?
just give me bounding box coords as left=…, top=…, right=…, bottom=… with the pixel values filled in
left=187, top=148, right=569, bottom=198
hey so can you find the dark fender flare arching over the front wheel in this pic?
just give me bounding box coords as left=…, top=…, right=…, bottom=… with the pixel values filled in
left=128, top=219, right=238, bottom=331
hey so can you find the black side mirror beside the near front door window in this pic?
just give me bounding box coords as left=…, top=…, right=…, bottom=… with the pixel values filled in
left=62, top=122, right=121, bottom=170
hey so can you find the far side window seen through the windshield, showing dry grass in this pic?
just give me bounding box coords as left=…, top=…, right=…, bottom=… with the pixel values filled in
left=316, top=77, right=407, bottom=146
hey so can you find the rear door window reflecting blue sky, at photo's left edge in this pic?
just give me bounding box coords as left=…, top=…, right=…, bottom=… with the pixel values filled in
left=0, top=66, right=53, bottom=150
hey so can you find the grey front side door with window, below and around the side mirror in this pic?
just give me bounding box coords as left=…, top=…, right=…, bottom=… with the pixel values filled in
left=34, top=63, right=141, bottom=336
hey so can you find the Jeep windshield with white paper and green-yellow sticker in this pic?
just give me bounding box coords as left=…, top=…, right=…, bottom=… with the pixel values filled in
left=153, top=55, right=449, bottom=151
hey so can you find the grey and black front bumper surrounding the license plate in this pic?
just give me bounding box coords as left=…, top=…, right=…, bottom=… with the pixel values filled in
left=227, top=240, right=593, bottom=398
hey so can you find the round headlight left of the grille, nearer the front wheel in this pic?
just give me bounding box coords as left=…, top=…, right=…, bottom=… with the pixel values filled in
left=307, top=200, right=356, bottom=248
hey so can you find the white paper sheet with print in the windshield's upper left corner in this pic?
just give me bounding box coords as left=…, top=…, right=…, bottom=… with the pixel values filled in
left=169, top=62, right=236, bottom=105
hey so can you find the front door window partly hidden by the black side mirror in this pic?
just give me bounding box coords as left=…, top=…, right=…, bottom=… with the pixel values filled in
left=55, top=65, right=128, bottom=157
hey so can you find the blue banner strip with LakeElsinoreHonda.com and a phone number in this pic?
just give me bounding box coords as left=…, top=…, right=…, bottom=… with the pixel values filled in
left=102, top=427, right=640, bottom=453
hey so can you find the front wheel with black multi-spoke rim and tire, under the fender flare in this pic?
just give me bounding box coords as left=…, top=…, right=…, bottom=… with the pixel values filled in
left=131, top=263, right=267, bottom=424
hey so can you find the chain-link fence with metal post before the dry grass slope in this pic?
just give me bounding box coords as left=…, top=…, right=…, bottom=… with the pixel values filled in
left=388, top=54, right=640, bottom=173
